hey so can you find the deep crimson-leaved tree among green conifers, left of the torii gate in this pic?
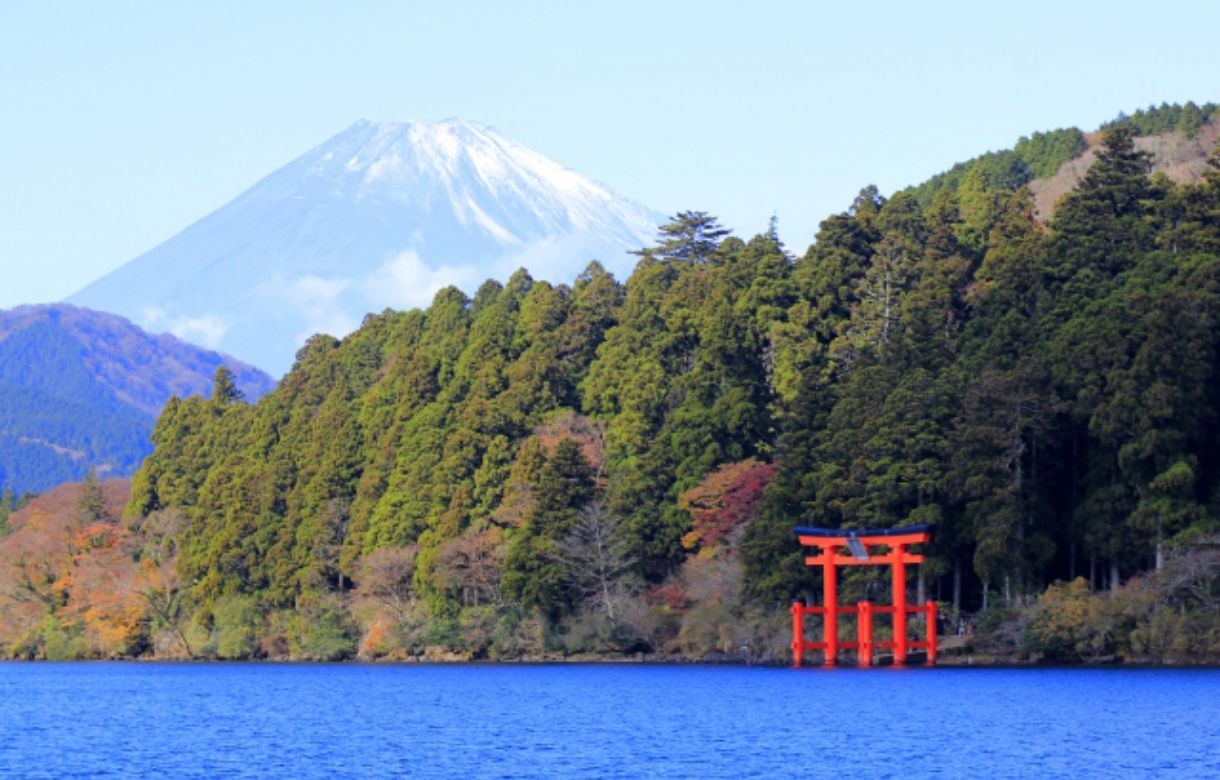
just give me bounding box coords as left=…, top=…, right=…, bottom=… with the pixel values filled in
left=678, top=458, right=780, bottom=553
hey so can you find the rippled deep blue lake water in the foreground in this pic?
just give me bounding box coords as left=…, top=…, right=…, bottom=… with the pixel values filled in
left=0, top=664, right=1220, bottom=779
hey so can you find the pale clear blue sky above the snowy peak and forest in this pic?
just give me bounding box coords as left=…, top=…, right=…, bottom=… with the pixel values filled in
left=0, top=0, right=1220, bottom=306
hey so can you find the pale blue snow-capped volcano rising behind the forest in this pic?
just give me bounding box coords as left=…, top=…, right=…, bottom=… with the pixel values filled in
left=70, top=120, right=660, bottom=372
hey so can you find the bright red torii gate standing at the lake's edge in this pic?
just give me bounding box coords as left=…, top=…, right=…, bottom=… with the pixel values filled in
left=792, top=525, right=936, bottom=666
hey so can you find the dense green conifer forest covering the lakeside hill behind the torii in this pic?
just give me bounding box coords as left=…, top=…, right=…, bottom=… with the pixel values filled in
left=0, top=112, right=1220, bottom=658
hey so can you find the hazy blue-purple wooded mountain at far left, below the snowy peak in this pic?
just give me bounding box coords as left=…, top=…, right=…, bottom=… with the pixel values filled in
left=0, top=304, right=273, bottom=493
